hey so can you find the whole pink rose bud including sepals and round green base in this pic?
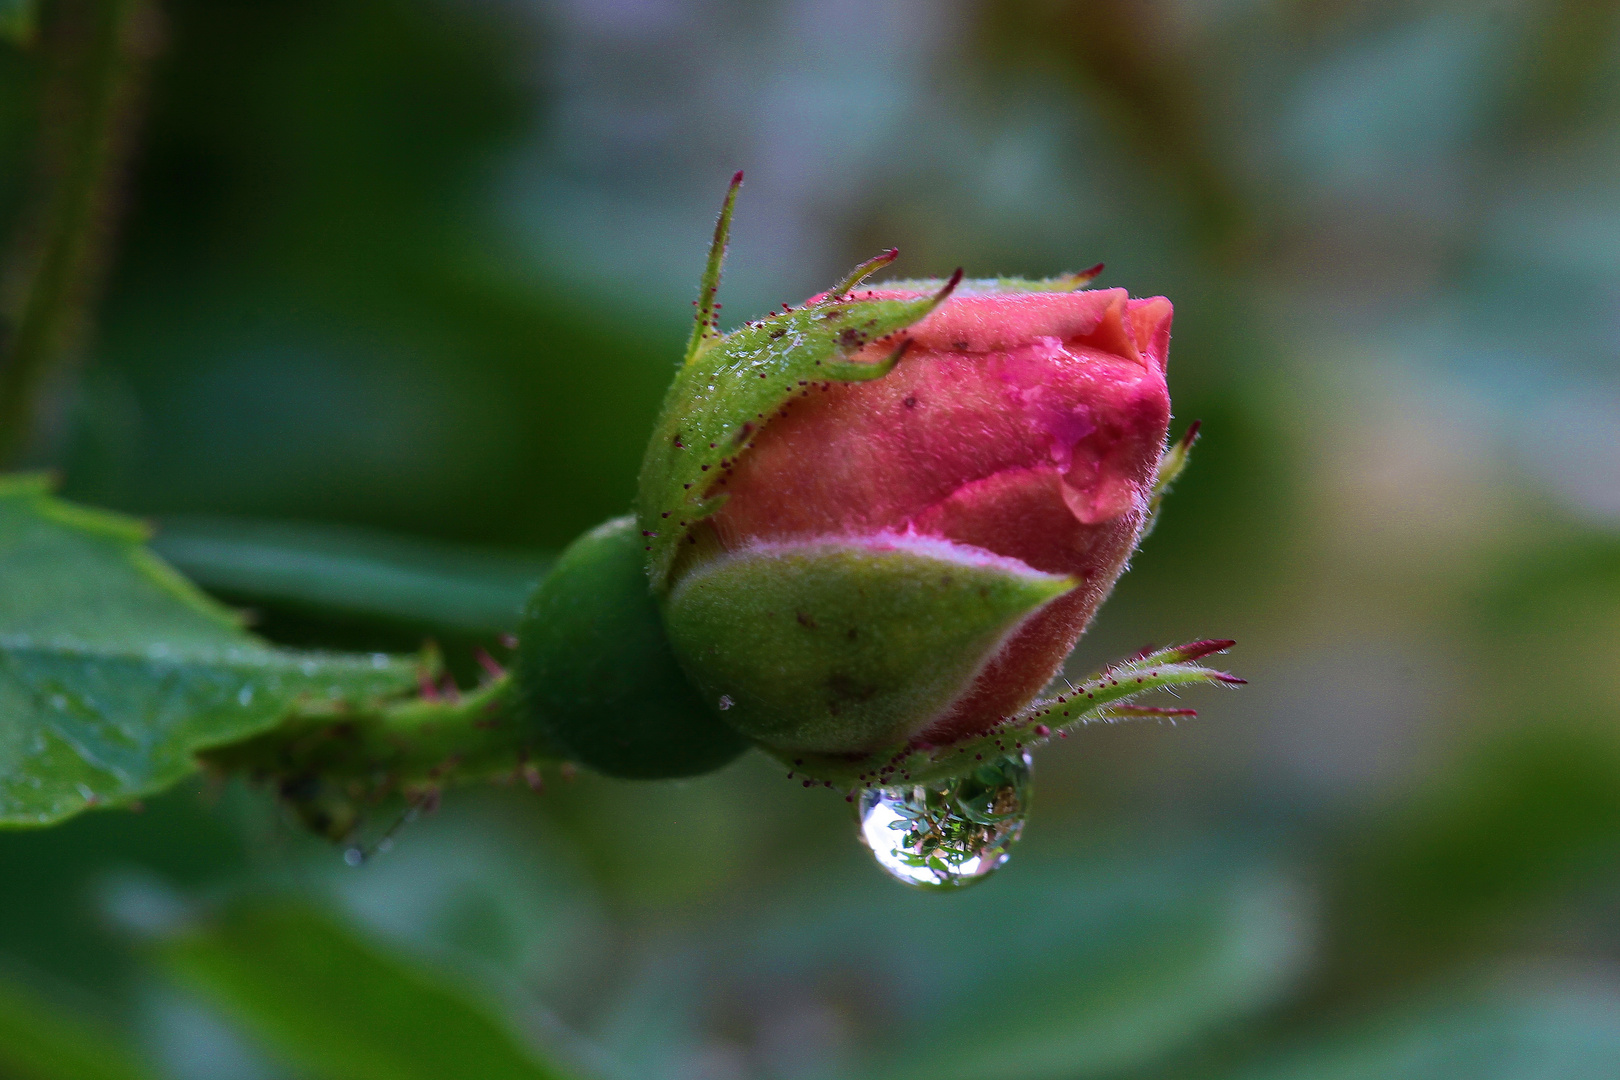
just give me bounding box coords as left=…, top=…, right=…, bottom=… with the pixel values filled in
left=518, top=175, right=1211, bottom=787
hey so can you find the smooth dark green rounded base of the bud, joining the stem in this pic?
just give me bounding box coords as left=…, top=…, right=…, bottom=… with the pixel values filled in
left=517, top=517, right=748, bottom=779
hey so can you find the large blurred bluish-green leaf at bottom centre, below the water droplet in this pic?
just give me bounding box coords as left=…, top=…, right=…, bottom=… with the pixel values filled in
left=598, top=850, right=1311, bottom=1080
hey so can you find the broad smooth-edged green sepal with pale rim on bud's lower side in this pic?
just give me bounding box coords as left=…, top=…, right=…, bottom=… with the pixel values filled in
left=664, top=536, right=1076, bottom=755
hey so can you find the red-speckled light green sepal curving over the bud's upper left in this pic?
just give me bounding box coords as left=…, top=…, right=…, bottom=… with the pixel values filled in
left=637, top=282, right=954, bottom=591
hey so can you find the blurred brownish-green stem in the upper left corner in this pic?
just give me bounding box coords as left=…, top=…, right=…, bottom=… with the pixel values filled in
left=0, top=0, right=157, bottom=468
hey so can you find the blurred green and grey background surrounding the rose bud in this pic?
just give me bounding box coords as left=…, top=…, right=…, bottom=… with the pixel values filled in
left=0, top=0, right=1620, bottom=1080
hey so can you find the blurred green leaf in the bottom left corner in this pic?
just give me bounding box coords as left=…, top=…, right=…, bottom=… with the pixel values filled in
left=0, top=983, right=152, bottom=1080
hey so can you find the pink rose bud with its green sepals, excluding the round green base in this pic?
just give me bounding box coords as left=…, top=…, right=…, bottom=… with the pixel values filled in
left=638, top=179, right=1171, bottom=758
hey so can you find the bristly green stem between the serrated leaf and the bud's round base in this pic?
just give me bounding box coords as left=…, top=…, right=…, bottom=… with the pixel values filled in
left=199, top=674, right=561, bottom=840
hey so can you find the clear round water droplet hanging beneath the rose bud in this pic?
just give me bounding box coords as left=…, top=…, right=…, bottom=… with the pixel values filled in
left=860, top=753, right=1030, bottom=889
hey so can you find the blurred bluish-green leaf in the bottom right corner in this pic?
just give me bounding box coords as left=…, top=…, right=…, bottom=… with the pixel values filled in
left=1230, top=976, right=1620, bottom=1080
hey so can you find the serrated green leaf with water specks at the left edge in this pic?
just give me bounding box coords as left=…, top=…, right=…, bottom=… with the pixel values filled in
left=0, top=476, right=415, bottom=826
